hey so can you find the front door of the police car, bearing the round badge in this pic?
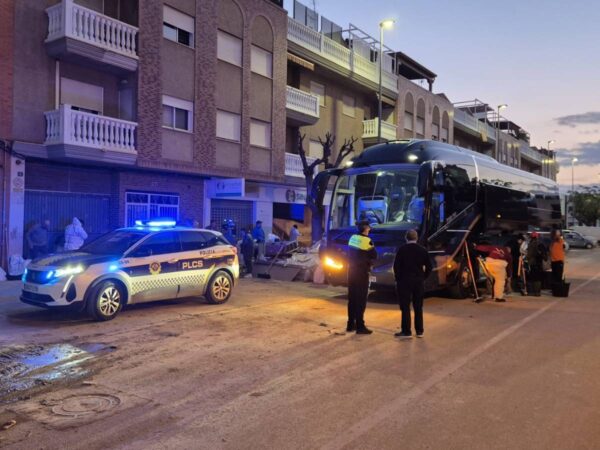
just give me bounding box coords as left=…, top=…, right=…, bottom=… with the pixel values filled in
left=126, top=231, right=181, bottom=303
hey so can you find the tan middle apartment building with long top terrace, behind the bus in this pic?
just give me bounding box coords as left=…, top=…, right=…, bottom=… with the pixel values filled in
left=274, top=1, right=453, bottom=239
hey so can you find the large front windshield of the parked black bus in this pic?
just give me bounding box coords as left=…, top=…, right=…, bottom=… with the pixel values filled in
left=329, top=167, right=424, bottom=229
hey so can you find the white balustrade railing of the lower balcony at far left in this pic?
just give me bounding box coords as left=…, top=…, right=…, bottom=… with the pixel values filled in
left=44, top=105, right=137, bottom=154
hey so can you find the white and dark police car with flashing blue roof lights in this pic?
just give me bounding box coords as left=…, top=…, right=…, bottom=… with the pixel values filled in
left=21, top=220, right=239, bottom=320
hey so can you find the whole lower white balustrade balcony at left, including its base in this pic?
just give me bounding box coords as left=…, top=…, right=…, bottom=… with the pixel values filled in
left=44, top=105, right=137, bottom=164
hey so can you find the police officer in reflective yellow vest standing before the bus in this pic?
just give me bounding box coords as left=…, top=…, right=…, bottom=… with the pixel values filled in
left=346, top=221, right=377, bottom=334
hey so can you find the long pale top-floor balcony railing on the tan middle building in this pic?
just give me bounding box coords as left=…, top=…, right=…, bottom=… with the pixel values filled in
left=288, top=17, right=398, bottom=92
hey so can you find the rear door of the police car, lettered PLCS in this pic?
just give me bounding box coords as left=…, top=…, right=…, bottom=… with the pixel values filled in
left=178, top=230, right=208, bottom=297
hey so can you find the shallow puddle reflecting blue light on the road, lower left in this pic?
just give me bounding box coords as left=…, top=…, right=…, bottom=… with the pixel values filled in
left=0, top=344, right=114, bottom=403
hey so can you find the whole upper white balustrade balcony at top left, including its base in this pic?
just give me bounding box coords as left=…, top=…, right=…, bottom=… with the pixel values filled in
left=45, top=0, right=138, bottom=74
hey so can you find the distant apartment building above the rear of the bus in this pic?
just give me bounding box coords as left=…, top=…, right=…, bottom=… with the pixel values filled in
left=454, top=99, right=558, bottom=180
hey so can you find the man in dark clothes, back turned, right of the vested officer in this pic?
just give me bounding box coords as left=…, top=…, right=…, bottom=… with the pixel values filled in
left=394, top=230, right=432, bottom=339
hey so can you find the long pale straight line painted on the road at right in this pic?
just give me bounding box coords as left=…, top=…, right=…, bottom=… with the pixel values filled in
left=321, top=272, right=600, bottom=450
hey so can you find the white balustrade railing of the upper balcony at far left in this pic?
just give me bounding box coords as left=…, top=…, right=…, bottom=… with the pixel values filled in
left=46, top=0, right=138, bottom=59
